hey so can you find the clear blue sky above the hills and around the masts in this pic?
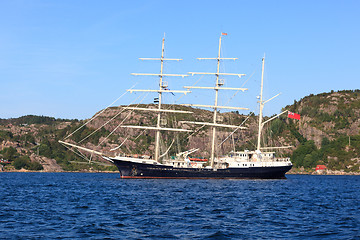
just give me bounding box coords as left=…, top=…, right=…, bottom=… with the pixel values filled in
left=0, top=0, right=360, bottom=119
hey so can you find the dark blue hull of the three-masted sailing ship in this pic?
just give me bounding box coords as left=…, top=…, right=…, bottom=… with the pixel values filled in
left=111, top=159, right=292, bottom=179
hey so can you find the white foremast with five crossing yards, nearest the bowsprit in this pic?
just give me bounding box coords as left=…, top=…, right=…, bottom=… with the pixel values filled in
left=129, top=37, right=191, bottom=161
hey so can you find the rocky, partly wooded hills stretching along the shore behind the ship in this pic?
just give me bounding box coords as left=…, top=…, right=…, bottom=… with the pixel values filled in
left=0, top=90, right=360, bottom=172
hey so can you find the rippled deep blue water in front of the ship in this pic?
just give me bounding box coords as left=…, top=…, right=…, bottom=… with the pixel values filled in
left=0, top=173, right=360, bottom=239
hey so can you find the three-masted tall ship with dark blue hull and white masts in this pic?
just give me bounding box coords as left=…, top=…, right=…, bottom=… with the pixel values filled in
left=59, top=33, right=292, bottom=179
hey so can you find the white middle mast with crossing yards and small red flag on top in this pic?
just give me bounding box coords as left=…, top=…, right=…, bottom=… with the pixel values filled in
left=183, top=33, right=248, bottom=168
